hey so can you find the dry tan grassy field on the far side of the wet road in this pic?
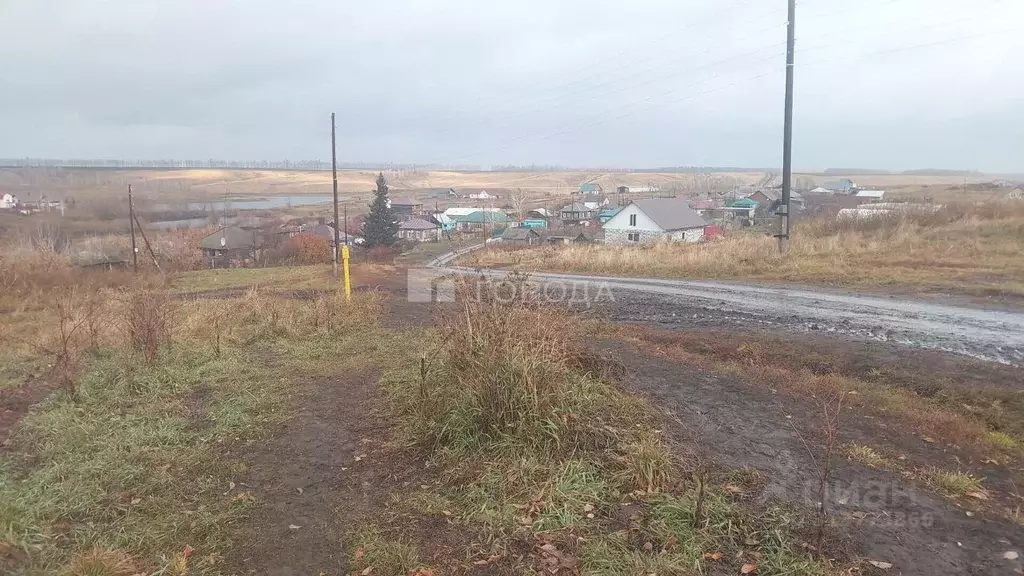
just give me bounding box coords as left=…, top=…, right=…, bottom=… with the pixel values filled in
left=461, top=202, right=1024, bottom=297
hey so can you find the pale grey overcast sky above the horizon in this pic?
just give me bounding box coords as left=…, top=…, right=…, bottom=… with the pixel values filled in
left=0, top=0, right=1024, bottom=172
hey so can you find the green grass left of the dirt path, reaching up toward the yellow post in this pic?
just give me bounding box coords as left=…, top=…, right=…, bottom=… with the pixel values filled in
left=0, top=292, right=389, bottom=576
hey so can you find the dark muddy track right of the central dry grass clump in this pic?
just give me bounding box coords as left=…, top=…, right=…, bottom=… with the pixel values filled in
left=600, top=342, right=1024, bottom=576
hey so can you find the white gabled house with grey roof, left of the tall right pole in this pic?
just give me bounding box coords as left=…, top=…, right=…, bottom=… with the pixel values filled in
left=602, top=198, right=708, bottom=244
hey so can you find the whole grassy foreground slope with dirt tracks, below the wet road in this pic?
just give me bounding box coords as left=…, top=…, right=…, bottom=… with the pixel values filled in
left=6, top=230, right=1024, bottom=576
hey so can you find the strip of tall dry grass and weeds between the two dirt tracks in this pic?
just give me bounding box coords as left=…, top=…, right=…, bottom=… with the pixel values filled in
left=378, top=279, right=824, bottom=576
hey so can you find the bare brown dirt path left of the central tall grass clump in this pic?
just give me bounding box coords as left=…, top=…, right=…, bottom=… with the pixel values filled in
left=231, top=362, right=387, bottom=576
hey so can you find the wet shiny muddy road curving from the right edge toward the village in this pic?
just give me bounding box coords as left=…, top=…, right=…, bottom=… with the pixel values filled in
left=435, top=259, right=1024, bottom=366
